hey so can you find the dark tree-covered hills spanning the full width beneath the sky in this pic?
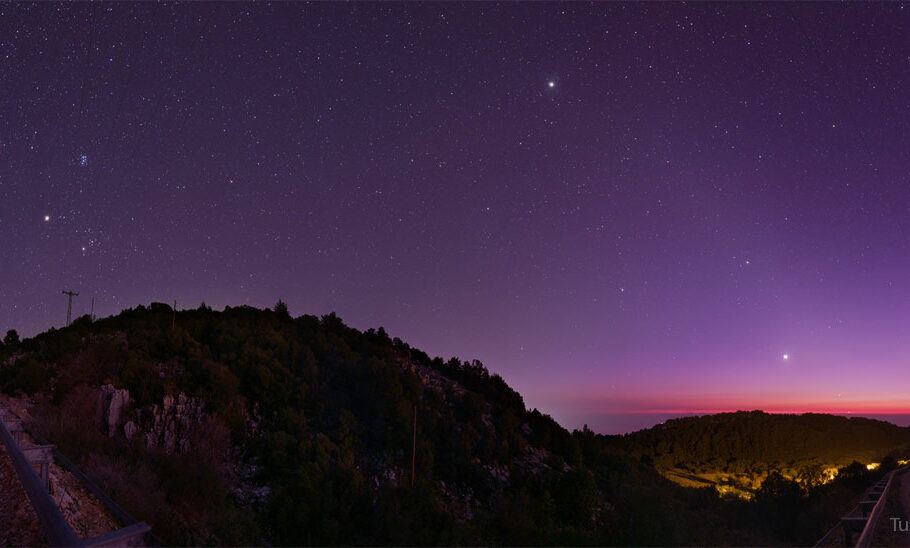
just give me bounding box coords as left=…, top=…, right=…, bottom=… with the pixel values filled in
left=0, top=303, right=904, bottom=545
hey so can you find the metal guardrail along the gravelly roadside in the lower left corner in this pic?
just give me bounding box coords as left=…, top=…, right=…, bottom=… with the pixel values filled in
left=0, top=407, right=154, bottom=547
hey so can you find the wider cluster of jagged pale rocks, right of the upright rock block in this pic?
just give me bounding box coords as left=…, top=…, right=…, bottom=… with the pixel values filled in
left=144, top=392, right=205, bottom=454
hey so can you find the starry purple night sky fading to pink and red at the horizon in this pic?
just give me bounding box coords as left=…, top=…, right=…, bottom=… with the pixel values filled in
left=0, top=3, right=910, bottom=432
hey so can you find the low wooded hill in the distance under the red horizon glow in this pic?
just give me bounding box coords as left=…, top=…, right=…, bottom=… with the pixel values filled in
left=609, top=411, right=910, bottom=488
